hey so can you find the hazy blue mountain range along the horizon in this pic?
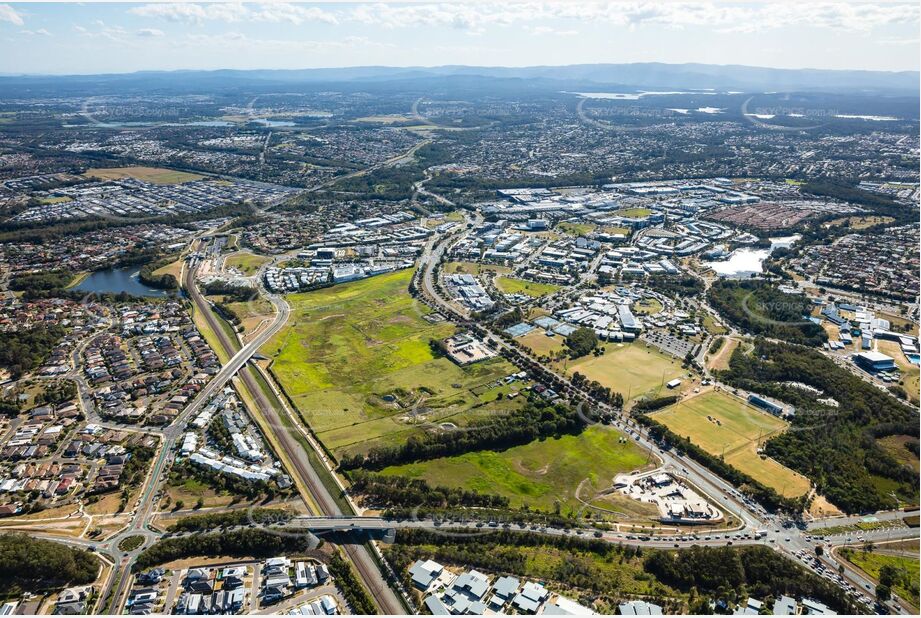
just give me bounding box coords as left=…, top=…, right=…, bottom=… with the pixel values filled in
left=0, top=62, right=921, bottom=96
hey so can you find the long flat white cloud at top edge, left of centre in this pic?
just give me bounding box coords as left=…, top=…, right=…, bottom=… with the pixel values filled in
left=129, top=2, right=338, bottom=25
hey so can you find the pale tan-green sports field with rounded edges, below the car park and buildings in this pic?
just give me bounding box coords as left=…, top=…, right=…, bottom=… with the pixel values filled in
left=566, top=343, right=684, bottom=400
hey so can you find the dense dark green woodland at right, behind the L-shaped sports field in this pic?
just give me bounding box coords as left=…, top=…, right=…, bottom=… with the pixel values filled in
left=718, top=339, right=919, bottom=513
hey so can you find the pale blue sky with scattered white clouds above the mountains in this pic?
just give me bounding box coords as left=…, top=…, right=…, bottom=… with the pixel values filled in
left=0, top=0, right=921, bottom=74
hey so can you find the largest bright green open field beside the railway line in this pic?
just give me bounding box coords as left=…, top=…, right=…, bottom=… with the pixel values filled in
left=262, top=270, right=521, bottom=456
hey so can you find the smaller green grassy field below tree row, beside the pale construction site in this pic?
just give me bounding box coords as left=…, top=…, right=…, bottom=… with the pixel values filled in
left=383, top=426, right=648, bottom=510
